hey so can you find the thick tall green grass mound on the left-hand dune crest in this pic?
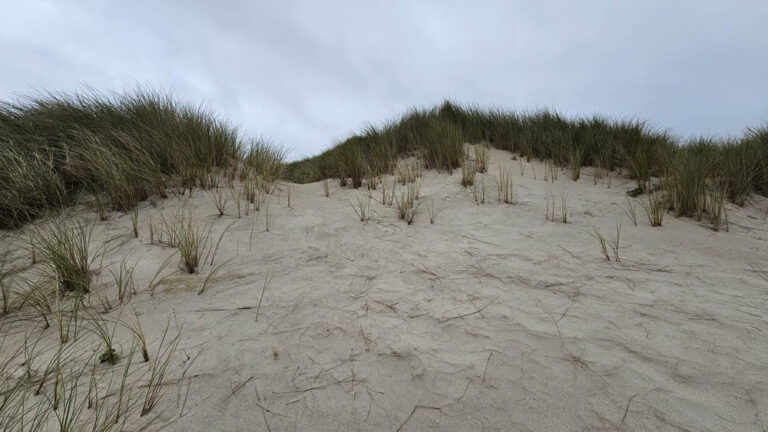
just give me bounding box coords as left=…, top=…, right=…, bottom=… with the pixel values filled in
left=0, top=89, right=244, bottom=229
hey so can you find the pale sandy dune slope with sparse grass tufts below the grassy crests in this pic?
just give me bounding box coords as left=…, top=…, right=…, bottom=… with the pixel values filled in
left=0, top=144, right=768, bottom=431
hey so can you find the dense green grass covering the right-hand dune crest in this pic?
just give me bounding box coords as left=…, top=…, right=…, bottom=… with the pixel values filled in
left=286, top=101, right=768, bottom=213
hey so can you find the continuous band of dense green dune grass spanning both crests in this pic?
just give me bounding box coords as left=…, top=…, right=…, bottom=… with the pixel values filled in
left=0, top=89, right=768, bottom=229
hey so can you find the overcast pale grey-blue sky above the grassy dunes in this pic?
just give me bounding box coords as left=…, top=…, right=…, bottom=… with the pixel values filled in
left=0, top=0, right=768, bottom=159
